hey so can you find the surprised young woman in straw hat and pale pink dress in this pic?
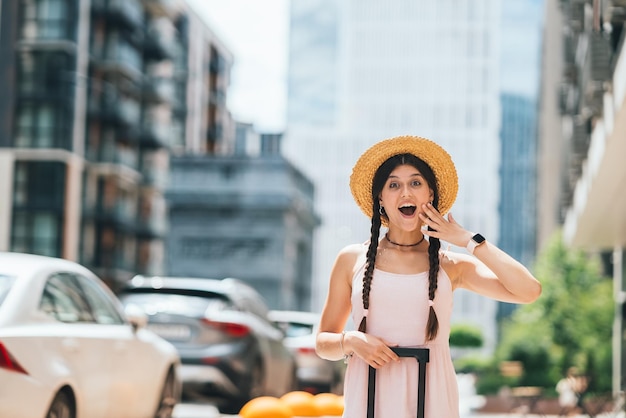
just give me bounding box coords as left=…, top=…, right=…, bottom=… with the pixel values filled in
left=316, top=136, right=541, bottom=418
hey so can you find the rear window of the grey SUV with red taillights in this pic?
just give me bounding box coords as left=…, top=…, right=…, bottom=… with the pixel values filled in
left=120, top=289, right=234, bottom=317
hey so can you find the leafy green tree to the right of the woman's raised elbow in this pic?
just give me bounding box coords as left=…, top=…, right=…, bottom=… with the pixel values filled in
left=497, top=233, right=613, bottom=392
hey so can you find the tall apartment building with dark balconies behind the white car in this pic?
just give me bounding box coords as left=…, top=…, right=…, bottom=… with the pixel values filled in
left=0, top=0, right=234, bottom=288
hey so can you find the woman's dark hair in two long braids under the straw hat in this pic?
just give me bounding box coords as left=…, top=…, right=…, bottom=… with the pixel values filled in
left=359, top=154, right=441, bottom=341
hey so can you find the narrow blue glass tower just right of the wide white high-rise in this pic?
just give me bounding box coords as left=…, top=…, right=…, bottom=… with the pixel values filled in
left=497, top=0, right=544, bottom=319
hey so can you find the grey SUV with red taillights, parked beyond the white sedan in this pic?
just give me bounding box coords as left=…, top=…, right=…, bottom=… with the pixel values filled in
left=120, top=276, right=296, bottom=413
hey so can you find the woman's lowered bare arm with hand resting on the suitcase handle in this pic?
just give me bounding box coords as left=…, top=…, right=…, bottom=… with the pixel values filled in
left=315, top=244, right=398, bottom=368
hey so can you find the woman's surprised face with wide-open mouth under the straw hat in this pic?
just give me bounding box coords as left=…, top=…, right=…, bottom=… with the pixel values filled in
left=380, top=164, right=433, bottom=231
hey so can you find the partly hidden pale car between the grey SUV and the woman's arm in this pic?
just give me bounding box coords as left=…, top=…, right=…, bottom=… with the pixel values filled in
left=269, top=310, right=345, bottom=394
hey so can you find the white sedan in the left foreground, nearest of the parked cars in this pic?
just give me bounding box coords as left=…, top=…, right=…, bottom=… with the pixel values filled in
left=0, top=252, right=180, bottom=418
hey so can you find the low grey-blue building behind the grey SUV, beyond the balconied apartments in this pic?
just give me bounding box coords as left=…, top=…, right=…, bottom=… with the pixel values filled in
left=167, top=130, right=319, bottom=311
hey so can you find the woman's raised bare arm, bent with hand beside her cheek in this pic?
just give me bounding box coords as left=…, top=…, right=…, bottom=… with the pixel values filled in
left=419, top=204, right=541, bottom=303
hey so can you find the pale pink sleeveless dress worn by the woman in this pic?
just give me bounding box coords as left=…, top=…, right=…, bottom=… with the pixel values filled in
left=343, top=267, right=459, bottom=418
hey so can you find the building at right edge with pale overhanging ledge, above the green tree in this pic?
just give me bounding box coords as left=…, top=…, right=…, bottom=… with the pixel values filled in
left=540, top=0, right=626, bottom=393
